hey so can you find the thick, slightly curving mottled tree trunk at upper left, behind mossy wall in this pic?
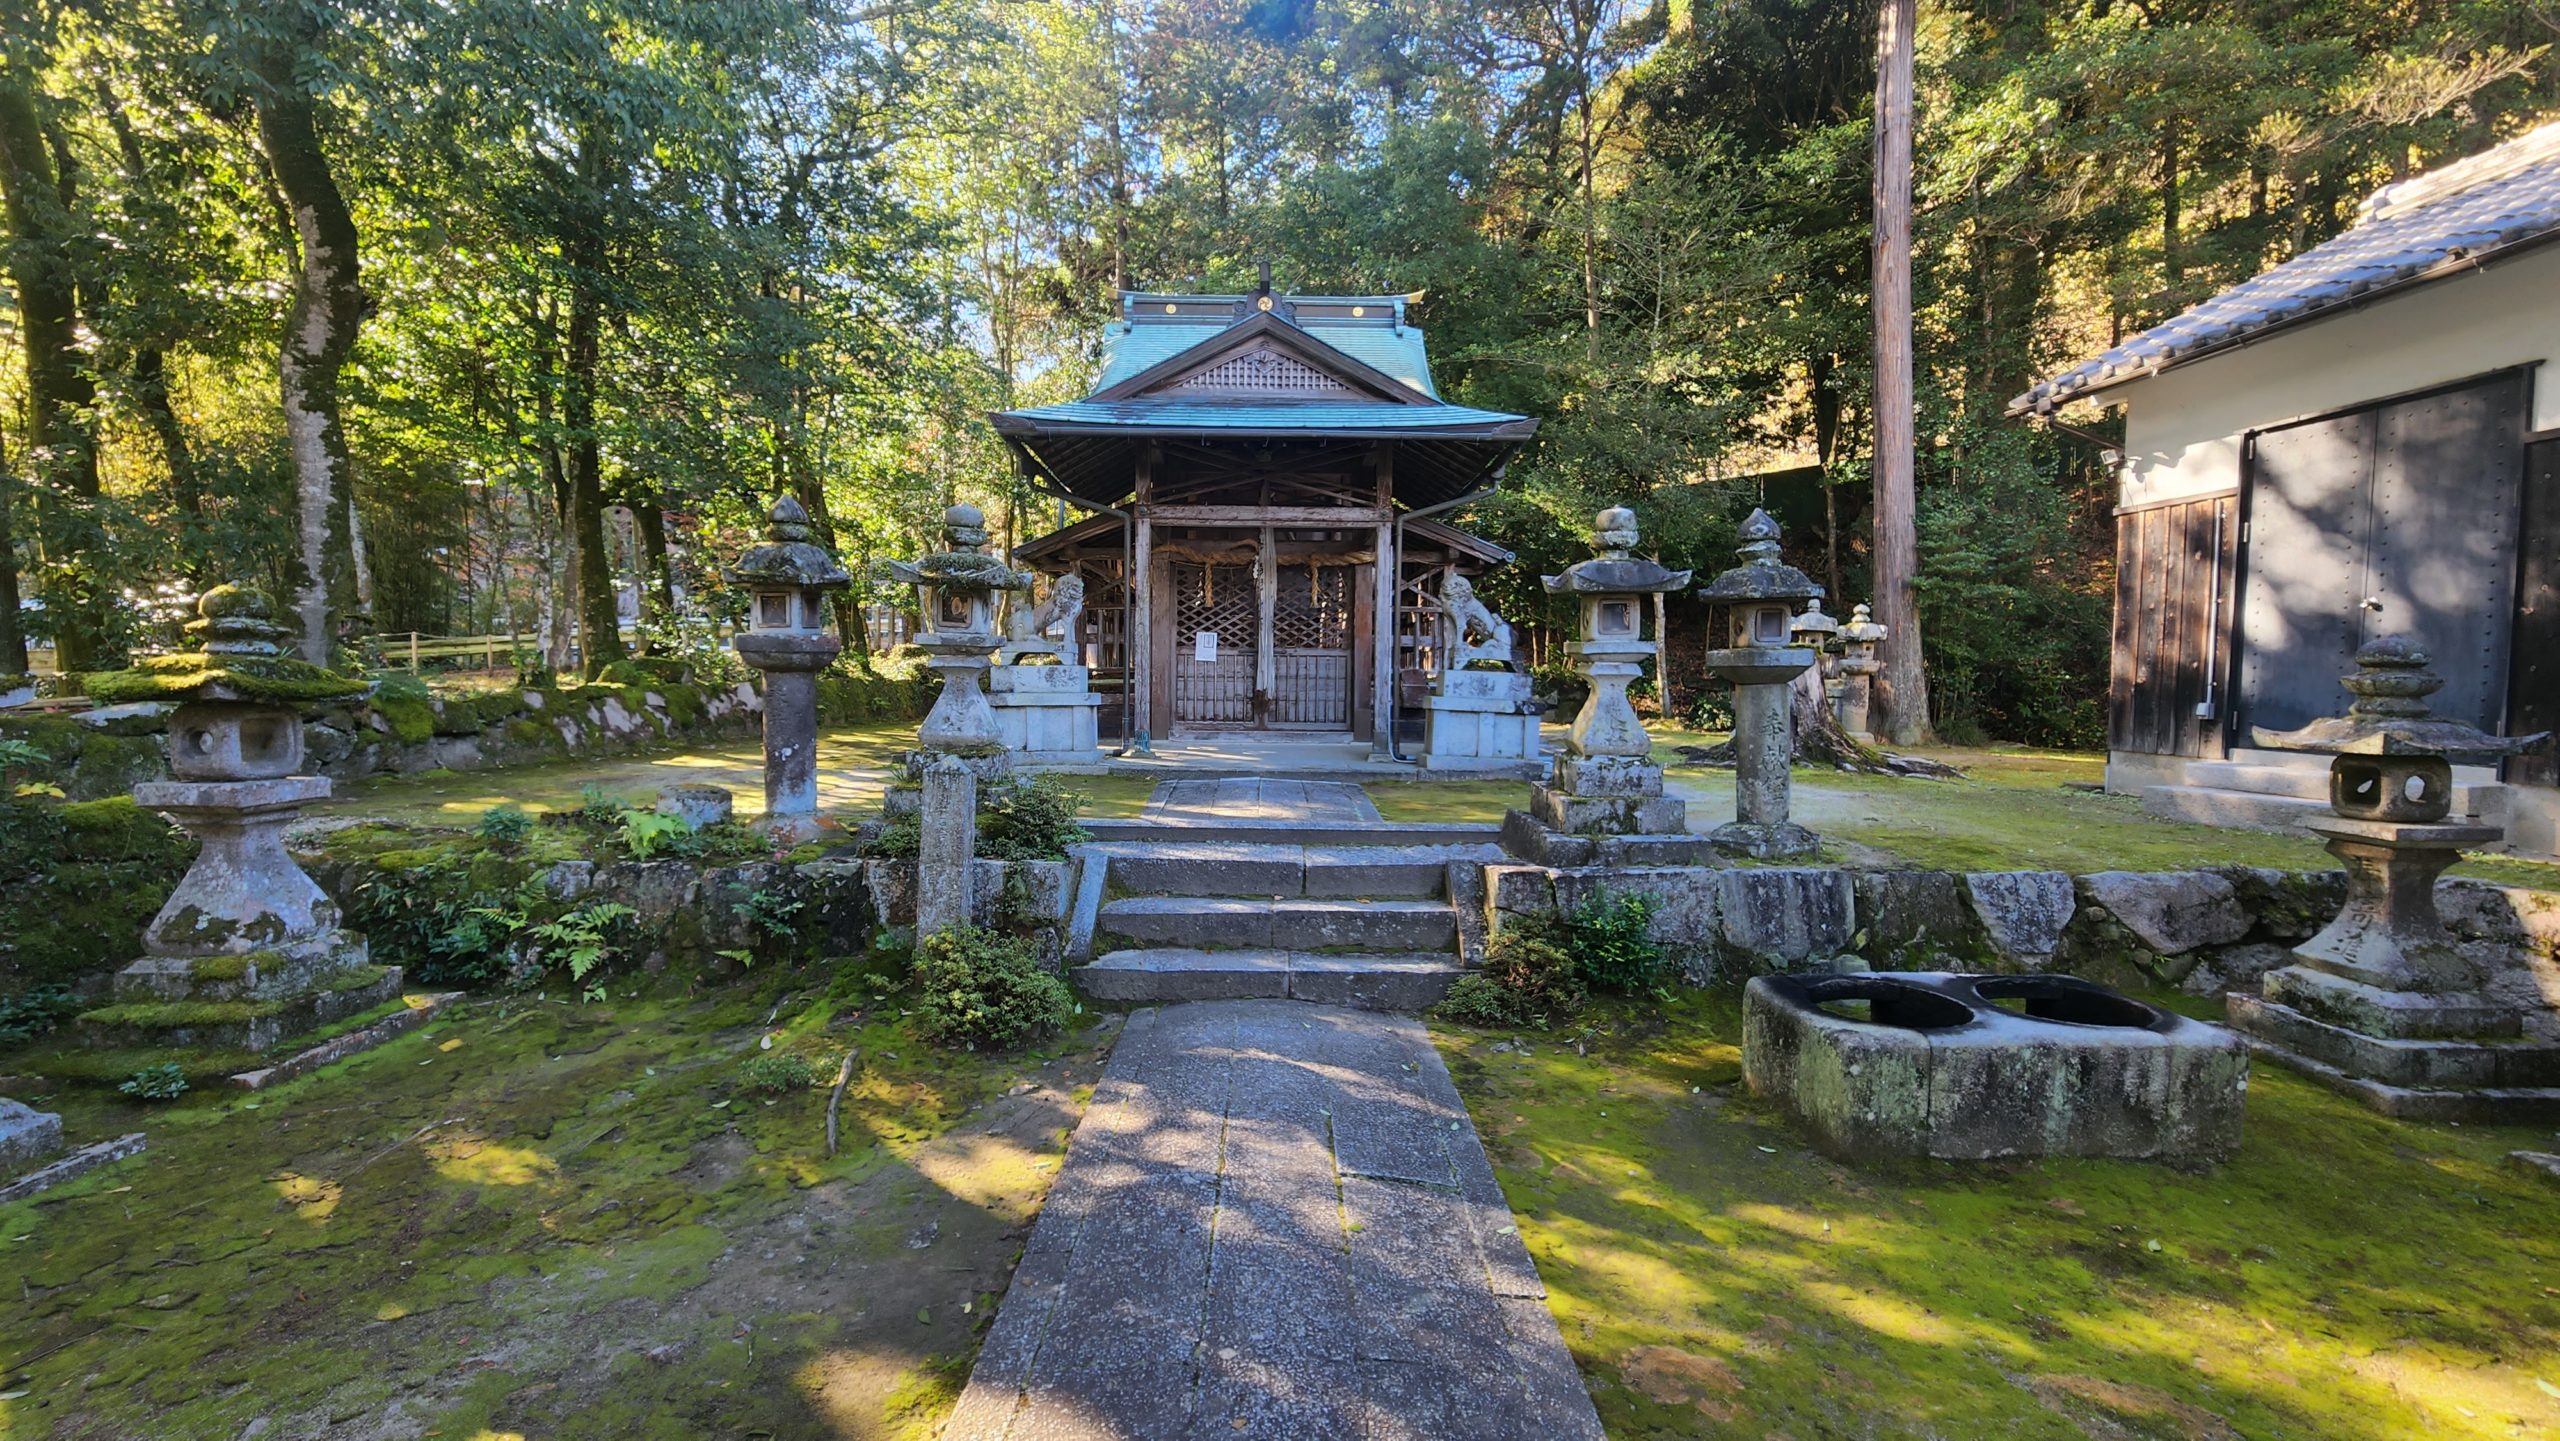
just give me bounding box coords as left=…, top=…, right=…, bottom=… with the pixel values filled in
left=256, top=22, right=371, bottom=665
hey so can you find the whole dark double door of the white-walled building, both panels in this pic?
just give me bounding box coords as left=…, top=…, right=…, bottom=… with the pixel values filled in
left=2237, top=371, right=2524, bottom=745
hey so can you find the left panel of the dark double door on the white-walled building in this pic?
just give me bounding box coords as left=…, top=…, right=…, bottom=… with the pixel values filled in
left=2237, top=410, right=2373, bottom=745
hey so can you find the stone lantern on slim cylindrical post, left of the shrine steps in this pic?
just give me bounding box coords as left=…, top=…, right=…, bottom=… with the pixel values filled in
left=730, top=497, right=852, bottom=840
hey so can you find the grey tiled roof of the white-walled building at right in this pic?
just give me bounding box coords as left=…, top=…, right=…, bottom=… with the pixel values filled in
left=2010, top=125, right=2560, bottom=415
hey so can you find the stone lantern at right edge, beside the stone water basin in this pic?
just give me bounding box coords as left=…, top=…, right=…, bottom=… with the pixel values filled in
left=2230, top=635, right=2560, bottom=1121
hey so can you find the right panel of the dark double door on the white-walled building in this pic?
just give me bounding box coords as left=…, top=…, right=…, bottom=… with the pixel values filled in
left=2363, top=371, right=2524, bottom=732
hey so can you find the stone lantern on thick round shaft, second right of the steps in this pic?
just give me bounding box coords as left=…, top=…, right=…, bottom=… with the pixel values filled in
left=1697, top=509, right=1828, bottom=860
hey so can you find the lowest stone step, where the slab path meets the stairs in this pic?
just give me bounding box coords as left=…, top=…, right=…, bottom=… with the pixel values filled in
left=1075, top=947, right=1467, bottom=1011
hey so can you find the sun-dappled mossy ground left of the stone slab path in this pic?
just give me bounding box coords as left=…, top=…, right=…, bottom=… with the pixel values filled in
left=0, top=967, right=1114, bottom=1441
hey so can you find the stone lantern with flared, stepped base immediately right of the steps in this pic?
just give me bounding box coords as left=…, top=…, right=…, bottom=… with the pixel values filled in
left=1531, top=507, right=1690, bottom=834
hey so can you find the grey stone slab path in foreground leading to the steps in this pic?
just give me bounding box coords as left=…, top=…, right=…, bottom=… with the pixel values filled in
left=942, top=1001, right=1603, bottom=1441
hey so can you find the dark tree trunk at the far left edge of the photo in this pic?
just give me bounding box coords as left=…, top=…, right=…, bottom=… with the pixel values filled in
left=0, top=69, right=105, bottom=671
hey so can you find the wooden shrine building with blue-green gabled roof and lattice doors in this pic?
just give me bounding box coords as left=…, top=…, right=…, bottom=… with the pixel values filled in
left=991, top=284, right=1539, bottom=752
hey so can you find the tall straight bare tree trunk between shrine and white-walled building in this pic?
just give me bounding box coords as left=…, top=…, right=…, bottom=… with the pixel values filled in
left=1871, top=0, right=1928, bottom=745
